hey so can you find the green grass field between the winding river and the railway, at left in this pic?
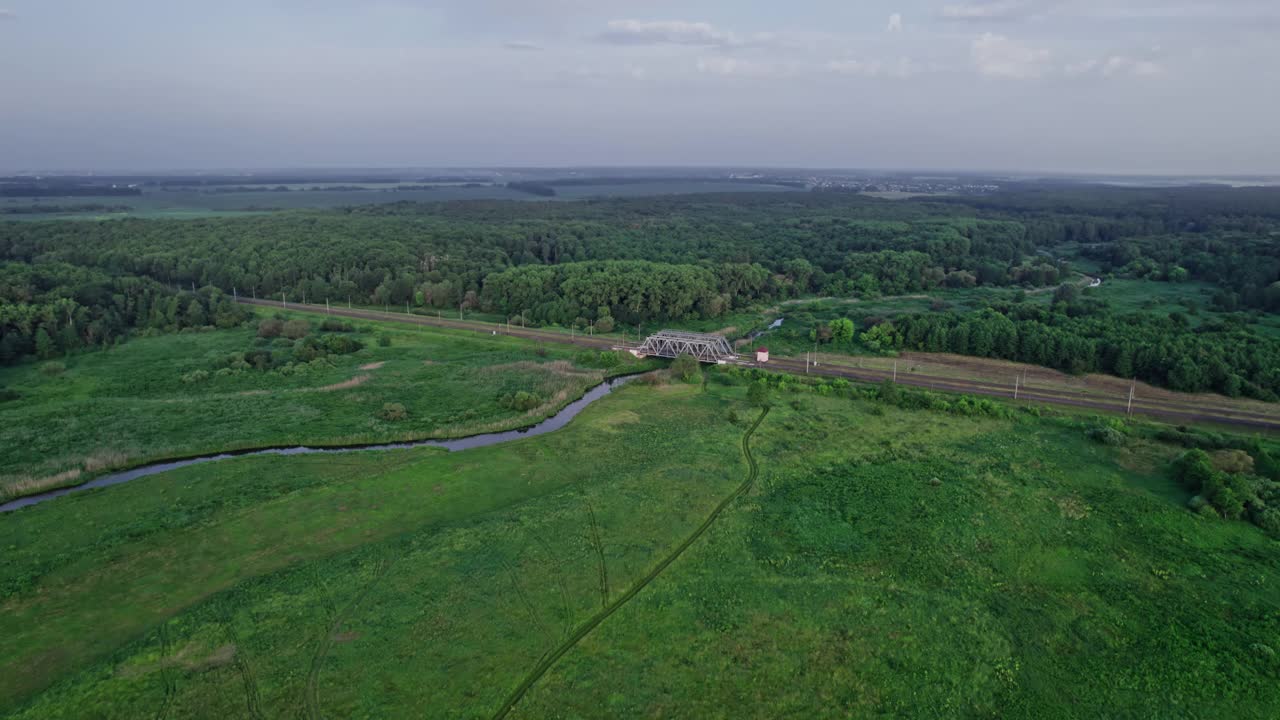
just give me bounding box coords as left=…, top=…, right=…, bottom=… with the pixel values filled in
left=0, top=311, right=650, bottom=493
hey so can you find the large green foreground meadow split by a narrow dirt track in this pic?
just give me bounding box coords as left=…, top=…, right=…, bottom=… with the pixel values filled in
left=0, top=383, right=1280, bottom=719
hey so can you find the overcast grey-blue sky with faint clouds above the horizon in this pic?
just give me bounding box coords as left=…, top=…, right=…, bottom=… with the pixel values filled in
left=0, top=0, right=1280, bottom=173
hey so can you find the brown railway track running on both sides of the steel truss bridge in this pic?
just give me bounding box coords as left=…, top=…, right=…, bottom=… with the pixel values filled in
left=239, top=297, right=1280, bottom=432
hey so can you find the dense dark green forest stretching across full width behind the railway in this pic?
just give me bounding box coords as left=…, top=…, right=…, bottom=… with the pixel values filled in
left=0, top=186, right=1280, bottom=400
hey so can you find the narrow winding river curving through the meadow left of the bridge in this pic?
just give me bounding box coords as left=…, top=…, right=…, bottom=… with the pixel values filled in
left=0, top=375, right=635, bottom=512
